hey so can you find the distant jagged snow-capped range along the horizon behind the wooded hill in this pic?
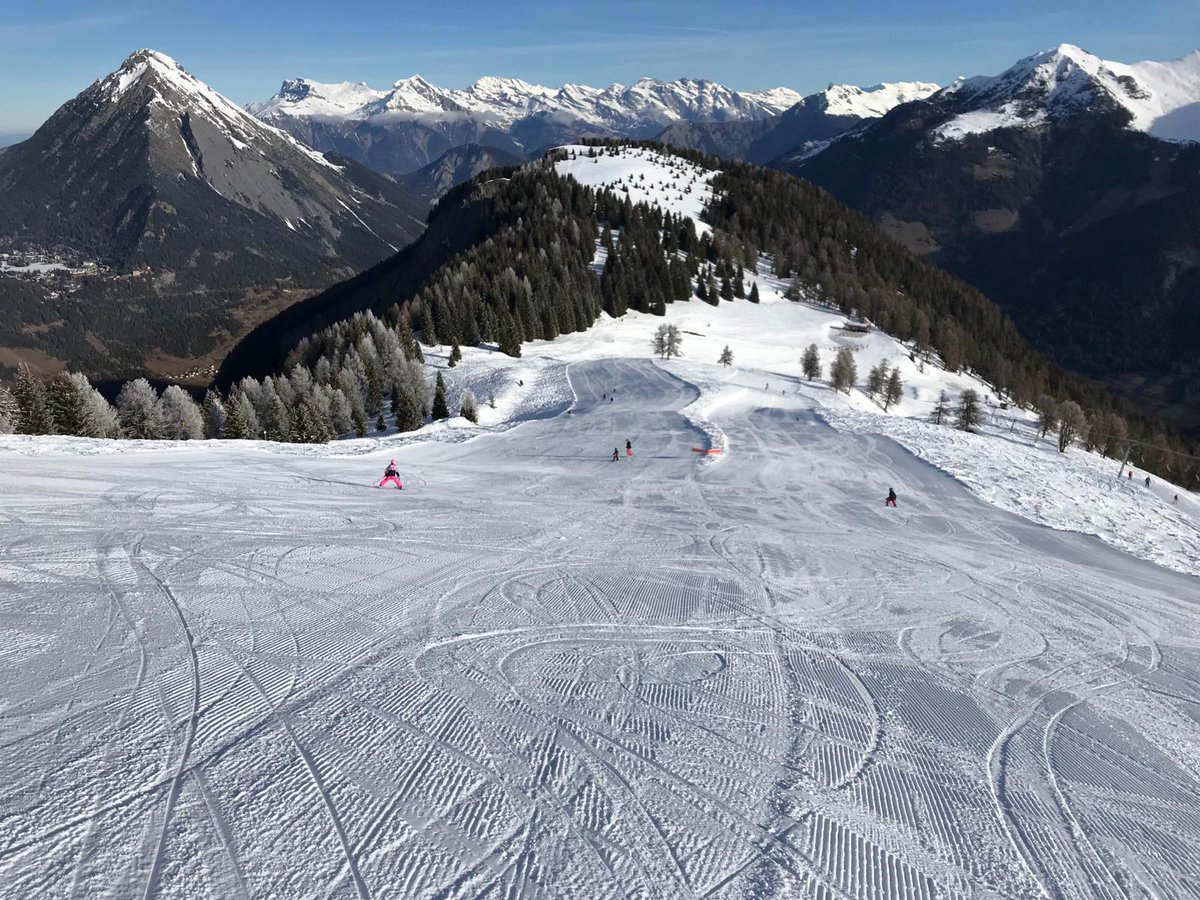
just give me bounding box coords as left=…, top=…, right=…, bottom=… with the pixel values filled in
left=247, top=76, right=799, bottom=175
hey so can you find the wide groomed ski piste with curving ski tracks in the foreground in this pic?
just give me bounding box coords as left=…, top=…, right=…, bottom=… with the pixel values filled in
left=0, top=360, right=1200, bottom=898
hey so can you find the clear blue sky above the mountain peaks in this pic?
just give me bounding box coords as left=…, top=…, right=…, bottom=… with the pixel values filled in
left=0, top=0, right=1200, bottom=138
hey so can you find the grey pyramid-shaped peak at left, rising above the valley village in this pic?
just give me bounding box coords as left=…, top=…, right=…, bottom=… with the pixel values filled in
left=0, top=50, right=420, bottom=275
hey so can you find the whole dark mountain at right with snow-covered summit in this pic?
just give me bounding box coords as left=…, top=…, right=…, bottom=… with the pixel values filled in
left=775, top=44, right=1200, bottom=431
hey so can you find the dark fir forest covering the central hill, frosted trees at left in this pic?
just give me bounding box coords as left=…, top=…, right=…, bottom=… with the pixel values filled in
left=0, top=148, right=1200, bottom=487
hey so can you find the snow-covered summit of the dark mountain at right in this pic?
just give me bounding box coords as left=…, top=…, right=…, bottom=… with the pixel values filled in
left=934, top=43, right=1200, bottom=140
